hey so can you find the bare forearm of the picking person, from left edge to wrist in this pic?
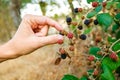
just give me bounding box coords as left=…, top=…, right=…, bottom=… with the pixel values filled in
left=0, top=40, right=18, bottom=62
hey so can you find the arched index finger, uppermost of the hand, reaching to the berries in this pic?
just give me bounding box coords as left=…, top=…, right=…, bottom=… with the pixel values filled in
left=24, top=14, right=63, bottom=31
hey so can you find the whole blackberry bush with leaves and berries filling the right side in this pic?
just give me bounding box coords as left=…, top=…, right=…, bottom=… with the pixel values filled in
left=55, top=0, right=120, bottom=80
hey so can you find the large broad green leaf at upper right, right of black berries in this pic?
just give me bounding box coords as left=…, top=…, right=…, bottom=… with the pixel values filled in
left=97, top=13, right=113, bottom=31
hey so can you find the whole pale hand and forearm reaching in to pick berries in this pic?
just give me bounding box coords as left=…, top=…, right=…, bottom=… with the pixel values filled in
left=0, top=14, right=63, bottom=62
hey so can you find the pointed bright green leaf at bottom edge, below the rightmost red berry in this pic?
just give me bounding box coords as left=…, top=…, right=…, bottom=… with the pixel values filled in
left=100, top=65, right=115, bottom=80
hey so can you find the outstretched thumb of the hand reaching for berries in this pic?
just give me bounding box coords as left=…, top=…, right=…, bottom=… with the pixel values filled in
left=38, top=35, right=63, bottom=47
